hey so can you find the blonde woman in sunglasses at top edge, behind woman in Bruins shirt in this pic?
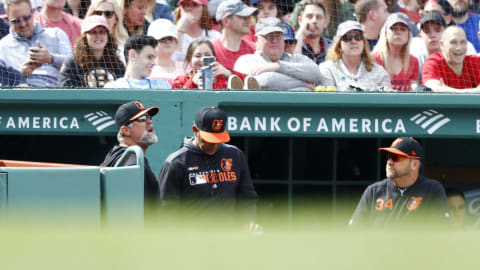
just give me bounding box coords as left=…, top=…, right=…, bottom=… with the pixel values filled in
left=86, top=0, right=128, bottom=64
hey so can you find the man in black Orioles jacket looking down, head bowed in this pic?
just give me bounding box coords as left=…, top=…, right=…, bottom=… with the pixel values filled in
left=158, top=107, right=258, bottom=231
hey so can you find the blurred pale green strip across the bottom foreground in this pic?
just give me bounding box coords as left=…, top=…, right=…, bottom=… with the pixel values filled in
left=0, top=209, right=480, bottom=270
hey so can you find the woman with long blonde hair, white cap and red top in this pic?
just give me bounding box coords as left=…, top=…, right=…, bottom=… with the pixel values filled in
left=372, top=13, right=419, bottom=92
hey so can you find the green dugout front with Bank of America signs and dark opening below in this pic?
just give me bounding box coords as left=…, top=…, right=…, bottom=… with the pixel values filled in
left=0, top=89, right=480, bottom=223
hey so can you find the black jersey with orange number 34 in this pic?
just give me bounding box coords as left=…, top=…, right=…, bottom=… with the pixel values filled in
left=350, top=176, right=449, bottom=227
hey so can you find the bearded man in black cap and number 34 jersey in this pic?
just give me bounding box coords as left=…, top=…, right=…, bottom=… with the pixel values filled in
left=349, top=137, right=449, bottom=228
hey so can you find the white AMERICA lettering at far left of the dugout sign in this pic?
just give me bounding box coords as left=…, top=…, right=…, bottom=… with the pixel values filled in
left=5, top=116, right=80, bottom=129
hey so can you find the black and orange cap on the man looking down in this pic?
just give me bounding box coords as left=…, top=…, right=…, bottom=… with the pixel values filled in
left=195, top=107, right=230, bottom=143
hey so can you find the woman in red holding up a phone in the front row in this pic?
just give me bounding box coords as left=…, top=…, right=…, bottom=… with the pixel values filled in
left=173, top=39, right=253, bottom=90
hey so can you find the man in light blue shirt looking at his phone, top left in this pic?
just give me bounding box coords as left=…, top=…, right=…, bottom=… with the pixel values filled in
left=0, top=0, right=72, bottom=87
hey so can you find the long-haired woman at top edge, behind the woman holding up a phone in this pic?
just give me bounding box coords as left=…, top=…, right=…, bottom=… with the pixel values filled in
left=172, top=0, right=220, bottom=61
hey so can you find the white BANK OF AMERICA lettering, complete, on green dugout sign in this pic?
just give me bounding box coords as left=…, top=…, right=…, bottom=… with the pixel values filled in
left=227, top=116, right=406, bottom=134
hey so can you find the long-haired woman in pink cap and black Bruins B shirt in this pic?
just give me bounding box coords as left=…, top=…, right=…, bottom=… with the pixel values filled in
left=60, top=15, right=125, bottom=88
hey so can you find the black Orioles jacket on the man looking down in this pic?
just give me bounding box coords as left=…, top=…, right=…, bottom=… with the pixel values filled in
left=158, top=138, right=257, bottom=213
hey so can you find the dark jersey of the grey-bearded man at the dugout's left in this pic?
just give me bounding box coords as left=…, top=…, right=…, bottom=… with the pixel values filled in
left=100, top=145, right=159, bottom=204
